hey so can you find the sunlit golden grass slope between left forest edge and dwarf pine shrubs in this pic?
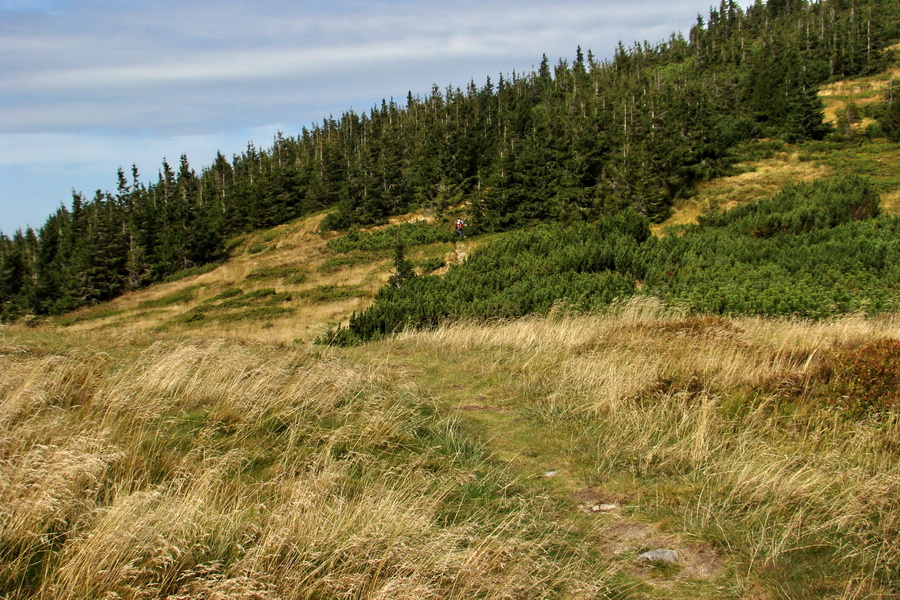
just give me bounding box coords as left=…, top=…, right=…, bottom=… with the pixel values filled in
left=52, top=215, right=466, bottom=343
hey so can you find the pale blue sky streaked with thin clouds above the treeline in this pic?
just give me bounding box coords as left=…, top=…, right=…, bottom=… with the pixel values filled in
left=0, top=0, right=748, bottom=235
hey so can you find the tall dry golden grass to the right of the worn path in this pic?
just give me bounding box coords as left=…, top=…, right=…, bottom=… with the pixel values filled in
left=394, top=302, right=900, bottom=599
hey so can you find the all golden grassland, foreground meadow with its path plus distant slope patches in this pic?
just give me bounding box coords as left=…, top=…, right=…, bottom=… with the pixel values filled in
left=0, top=63, right=900, bottom=600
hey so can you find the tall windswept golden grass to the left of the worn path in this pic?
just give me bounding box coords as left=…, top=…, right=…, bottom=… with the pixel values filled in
left=0, top=329, right=603, bottom=600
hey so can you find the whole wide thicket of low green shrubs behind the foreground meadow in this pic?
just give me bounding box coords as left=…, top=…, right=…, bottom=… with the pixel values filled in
left=322, top=177, right=900, bottom=344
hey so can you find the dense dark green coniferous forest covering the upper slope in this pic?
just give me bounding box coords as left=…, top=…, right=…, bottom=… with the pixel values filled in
left=0, top=0, right=900, bottom=328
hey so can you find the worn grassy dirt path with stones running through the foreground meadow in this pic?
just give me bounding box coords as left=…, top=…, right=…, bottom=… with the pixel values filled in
left=370, top=354, right=746, bottom=599
